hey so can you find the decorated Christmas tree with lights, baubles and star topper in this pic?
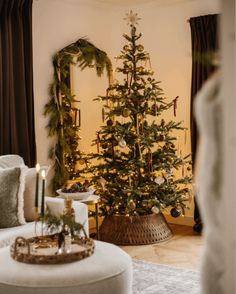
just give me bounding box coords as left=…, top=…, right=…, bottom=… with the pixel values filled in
left=90, top=11, right=191, bottom=217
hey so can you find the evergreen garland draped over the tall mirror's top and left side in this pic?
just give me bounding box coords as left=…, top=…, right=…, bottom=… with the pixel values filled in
left=44, top=38, right=112, bottom=191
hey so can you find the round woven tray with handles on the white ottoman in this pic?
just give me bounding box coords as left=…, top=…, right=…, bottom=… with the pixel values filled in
left=10, top=235, right=95, bottom=264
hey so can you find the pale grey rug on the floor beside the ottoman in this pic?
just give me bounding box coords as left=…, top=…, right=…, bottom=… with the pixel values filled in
left=133, top=260, right=200, bottom=294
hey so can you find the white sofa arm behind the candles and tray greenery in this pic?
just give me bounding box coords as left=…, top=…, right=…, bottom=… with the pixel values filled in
left=45, top=197, right=89, bottom=235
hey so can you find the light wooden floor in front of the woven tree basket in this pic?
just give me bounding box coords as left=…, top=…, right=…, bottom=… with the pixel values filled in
left=121, top=225, right=203, bottom=270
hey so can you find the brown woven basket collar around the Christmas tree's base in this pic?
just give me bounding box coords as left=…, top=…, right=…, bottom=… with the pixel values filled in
left=100, top=213, right=172, bottom=245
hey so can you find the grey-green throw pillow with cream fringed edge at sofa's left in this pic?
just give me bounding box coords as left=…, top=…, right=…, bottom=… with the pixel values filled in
left=0, top=167, right=25, bottom=228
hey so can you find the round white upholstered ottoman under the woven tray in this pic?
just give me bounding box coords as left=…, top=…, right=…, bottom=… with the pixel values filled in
left=0, top=241, right=132, bottom=294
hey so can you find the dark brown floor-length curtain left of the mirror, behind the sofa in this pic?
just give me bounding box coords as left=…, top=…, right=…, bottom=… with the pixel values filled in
left=0, top=0, right=36, bottom=166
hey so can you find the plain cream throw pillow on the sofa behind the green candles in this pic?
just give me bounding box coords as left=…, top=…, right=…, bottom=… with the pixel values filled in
left=24, top=166, right=49, bottom=221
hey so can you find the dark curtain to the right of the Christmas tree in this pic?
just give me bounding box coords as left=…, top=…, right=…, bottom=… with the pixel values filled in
left=190, top=14, right=218, bottom=232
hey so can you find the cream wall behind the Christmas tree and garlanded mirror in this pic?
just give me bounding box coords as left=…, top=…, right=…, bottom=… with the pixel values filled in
left=33, top=0, right=220, bottom=224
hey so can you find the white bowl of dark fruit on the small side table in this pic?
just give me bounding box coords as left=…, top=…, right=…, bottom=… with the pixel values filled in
left=56, top=181, right=95, bottom=200
